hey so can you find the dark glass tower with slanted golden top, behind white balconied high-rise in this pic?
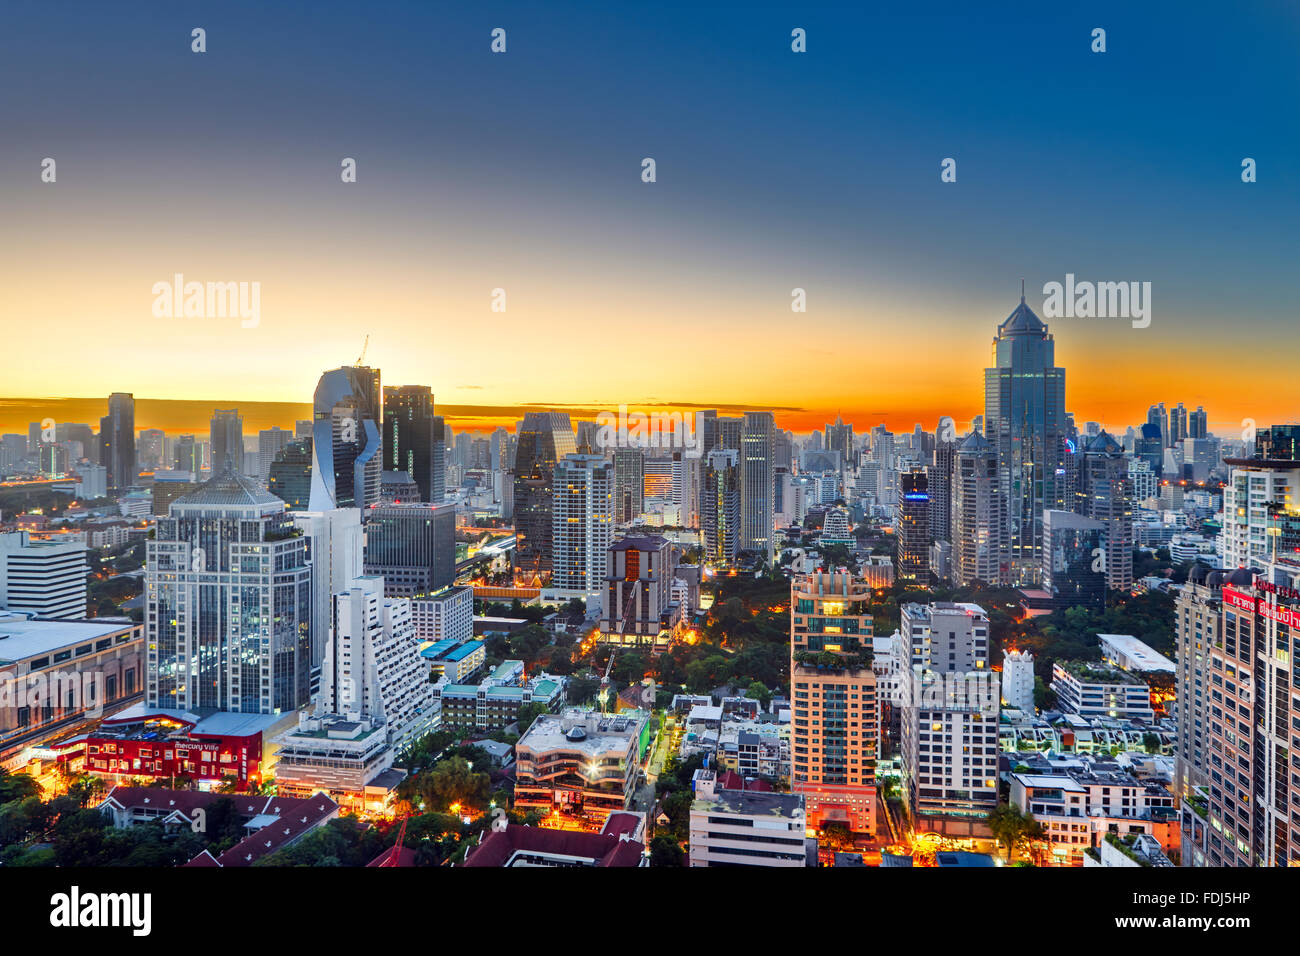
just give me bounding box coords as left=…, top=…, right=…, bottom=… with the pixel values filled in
left=515, top=411, right=577, bottom=578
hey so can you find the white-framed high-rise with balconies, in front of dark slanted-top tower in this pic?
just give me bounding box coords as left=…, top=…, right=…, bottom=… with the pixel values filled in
left=551, top=454, right=614, bottom=598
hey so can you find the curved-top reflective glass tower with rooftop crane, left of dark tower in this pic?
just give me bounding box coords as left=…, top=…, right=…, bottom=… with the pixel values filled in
left=309, top=365, right=384, bottom=514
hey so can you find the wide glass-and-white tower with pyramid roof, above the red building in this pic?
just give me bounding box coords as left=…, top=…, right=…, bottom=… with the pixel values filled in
left=144, top=468, right=312, bottom=714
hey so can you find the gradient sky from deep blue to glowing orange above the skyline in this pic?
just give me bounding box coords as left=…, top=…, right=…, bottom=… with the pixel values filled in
left=0, top=0, right=1300, bottom=431
